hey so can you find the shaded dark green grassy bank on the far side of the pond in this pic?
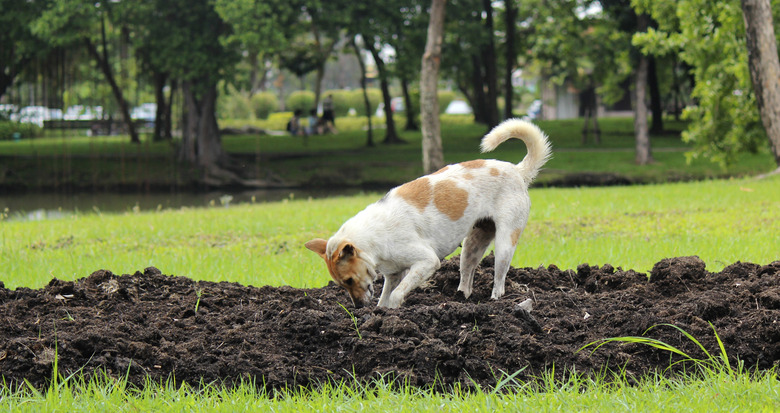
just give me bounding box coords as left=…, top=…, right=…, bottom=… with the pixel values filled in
left=0, top=116, right=774, bottom=191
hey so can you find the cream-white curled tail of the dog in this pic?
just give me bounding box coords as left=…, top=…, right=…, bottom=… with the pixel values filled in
left=480, top=119, right=552, bottom=183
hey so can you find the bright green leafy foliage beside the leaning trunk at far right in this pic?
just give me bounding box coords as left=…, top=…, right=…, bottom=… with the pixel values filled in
left=632, top=0, right=780, bottom=165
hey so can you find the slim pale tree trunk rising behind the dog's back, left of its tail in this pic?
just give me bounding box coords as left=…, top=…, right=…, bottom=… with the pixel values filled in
left=420, top=0, right=446, bottom=174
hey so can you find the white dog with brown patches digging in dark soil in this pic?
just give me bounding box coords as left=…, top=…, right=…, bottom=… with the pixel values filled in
left=306, top=119, right=552, bottom=308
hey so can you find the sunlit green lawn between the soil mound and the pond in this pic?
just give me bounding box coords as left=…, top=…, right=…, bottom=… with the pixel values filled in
left=0, top=177, right=780, bottom=288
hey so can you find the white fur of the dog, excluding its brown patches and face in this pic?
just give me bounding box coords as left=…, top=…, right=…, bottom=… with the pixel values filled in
left=316, top=119, right=550, bottom=308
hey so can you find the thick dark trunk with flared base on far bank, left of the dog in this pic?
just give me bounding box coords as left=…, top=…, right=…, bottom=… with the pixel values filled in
left=179, top=81, right=224, bottom=168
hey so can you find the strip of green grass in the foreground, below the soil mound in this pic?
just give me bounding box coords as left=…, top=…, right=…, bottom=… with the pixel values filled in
left=0, top=356, right=780, bottom=412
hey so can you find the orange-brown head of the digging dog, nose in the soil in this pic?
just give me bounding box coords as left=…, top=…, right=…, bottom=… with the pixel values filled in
left=306, top=238, right=376, bottom=308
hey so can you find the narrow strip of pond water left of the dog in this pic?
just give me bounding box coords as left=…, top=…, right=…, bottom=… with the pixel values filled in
left=0, top=188, right=381, bottom=221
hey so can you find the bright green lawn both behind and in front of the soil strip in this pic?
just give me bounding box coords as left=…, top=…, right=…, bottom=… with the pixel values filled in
left=0, top=177, right=780, bottom=412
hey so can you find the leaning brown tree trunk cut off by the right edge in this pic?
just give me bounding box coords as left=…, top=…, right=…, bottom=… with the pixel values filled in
left=742, top=0, right=780, bottom=171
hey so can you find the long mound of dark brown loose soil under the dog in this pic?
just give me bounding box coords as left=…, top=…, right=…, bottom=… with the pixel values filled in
left=0, top=256, right=780, bottom=389
